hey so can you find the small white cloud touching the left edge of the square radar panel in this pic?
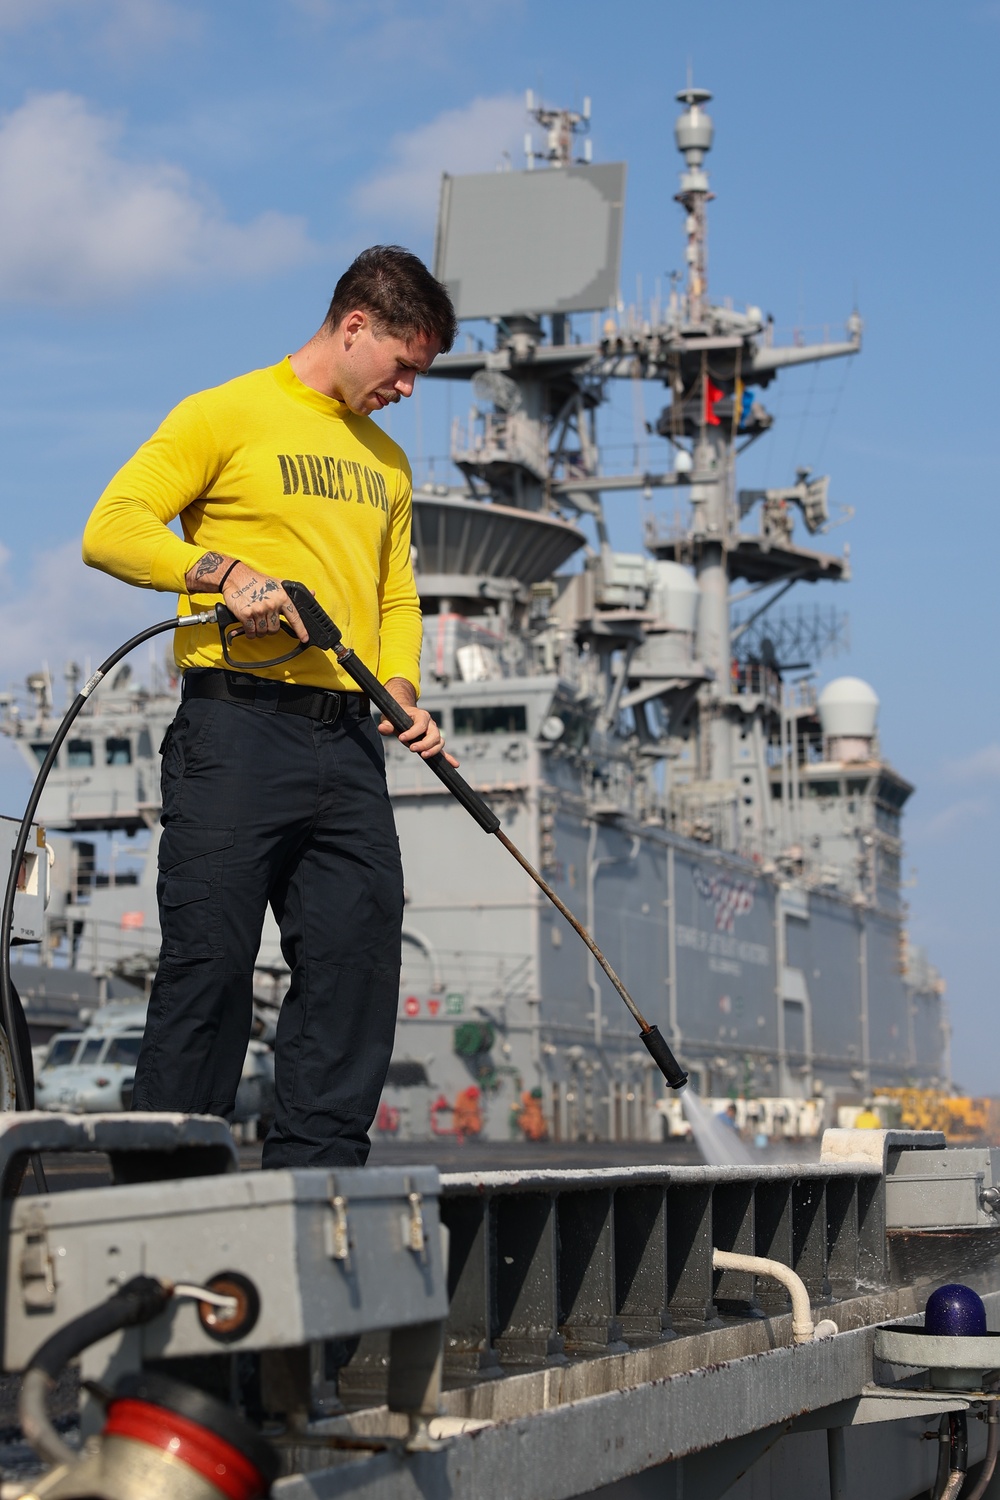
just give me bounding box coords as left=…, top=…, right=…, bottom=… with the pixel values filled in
left=354, top=95, right=525, bottom=228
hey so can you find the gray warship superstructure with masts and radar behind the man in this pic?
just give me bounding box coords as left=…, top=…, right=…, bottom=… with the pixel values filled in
left=0, top=87, right=949, bottom=1140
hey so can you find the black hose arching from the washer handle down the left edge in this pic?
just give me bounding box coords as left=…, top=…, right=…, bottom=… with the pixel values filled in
left=0, top=609, right=216, bottom=1193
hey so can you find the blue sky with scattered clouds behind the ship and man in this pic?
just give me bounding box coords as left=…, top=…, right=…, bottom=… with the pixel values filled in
left=0, top=0, right=1000, bottom=1092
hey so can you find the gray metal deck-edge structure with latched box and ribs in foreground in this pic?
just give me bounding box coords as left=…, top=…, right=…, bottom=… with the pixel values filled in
left=0, top=1113, right=1000, bottom=1500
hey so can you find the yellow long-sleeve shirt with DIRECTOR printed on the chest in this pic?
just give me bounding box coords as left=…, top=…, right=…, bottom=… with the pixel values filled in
left=84, top=360, right=421, bottom=690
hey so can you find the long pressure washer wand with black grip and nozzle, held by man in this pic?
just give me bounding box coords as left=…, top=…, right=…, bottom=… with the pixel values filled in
left=282, top=579, right=688, bottom=1089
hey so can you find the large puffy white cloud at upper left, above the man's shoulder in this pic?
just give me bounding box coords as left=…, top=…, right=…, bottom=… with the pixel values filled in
left=0, top=93, right=312, bottom=303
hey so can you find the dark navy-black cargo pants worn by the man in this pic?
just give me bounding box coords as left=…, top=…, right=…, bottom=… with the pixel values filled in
left=133, top=675, right=403, bottom=1167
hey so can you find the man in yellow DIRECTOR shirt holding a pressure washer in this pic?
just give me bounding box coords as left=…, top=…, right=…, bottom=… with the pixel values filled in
left=84, top=246, right=456, bottom=1167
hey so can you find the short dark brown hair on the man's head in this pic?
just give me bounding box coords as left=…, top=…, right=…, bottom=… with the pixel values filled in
left=324, top=245, right=459, bottom=354
